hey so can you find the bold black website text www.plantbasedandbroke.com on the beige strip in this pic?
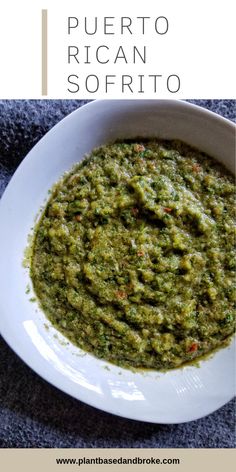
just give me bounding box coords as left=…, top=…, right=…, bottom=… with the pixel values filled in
left=56, top=456, right=180, bottom=467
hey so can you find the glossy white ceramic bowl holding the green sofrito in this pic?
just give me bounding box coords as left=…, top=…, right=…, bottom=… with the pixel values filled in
left=0, top=100, right=235, bottom=423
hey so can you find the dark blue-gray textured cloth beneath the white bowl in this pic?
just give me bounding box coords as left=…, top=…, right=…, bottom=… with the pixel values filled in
left=0, top=100, right=235, bottom=448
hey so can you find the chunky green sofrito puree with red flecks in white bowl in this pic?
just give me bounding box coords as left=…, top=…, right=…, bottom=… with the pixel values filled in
left=31, top=139, right=236, bottom=370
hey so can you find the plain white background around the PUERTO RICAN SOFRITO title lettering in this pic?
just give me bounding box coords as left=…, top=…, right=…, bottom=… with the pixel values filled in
left=0, top=0, right=236, bottom=99
